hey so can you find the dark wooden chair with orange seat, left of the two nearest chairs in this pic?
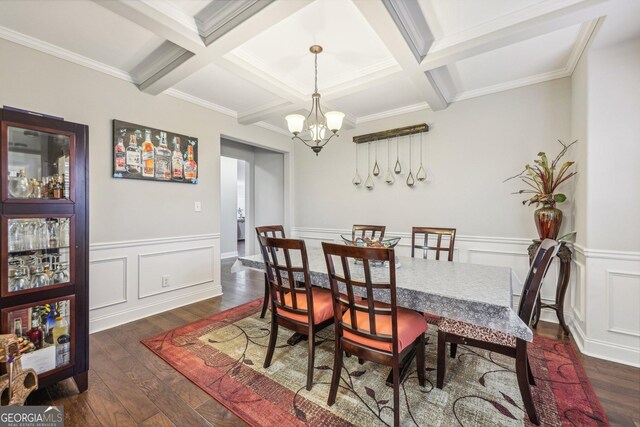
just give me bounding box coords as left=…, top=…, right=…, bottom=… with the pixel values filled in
left=259, top=236, right=334, bottom=390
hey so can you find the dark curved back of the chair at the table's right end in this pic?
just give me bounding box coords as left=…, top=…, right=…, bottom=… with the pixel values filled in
left=518, top=239, right=562, bottom=325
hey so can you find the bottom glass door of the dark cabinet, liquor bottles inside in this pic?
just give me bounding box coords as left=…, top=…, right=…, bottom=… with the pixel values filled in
left=2, top=295, right=76, bottom=375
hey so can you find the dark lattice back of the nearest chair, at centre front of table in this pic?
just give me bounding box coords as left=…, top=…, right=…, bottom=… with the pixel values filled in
left=322, top=242, right=398, bottom=354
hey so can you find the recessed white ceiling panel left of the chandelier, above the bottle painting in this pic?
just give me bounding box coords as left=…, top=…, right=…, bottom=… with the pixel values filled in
left=174, top=64, right=276, bottom=111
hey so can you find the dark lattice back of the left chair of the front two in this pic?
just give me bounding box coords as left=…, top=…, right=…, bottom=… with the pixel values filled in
left=258, top=236, right=313, bottom=324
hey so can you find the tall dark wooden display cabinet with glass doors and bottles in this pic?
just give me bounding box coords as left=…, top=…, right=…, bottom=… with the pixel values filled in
left=0, top=109, right=89, bottom=392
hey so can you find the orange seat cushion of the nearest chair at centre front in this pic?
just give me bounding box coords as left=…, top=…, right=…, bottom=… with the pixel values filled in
left=342, top=304, right=427, bottom=353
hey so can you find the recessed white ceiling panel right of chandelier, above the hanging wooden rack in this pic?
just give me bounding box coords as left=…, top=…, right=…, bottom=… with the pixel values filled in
left=324, top=76, right=424, bottom=117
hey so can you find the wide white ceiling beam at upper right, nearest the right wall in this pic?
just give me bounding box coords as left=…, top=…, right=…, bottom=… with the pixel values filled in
left=420, top=0, right=608, bottom=72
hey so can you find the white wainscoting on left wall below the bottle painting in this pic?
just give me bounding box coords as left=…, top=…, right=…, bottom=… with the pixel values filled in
left=89, top=234, right=222, bottom=333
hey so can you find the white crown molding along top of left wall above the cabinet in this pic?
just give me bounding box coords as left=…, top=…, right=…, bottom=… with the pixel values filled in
left=0, top=27, right=138, bottom=84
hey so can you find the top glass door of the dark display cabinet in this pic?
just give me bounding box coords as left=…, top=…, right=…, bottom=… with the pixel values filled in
left=2, top=123, right=75, bottom=201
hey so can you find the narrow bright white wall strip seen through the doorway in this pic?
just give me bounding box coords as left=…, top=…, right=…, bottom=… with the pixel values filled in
left=220, top=156, right=238, bottom=258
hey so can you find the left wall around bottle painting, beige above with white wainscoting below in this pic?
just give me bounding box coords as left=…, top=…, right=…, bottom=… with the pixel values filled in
left=0, top=40, right=291, bottom=331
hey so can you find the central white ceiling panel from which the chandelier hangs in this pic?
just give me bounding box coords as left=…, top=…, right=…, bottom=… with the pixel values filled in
left=226, top=0, right=396, bottom=94
